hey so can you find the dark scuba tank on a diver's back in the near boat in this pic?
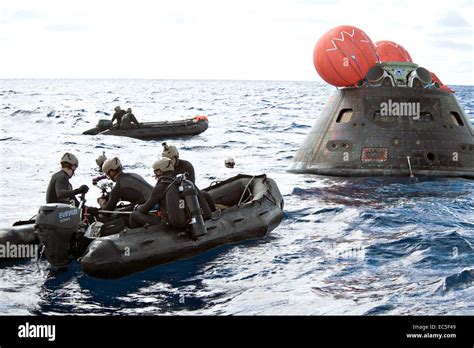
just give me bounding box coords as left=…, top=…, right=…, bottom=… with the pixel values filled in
left=177, top=175, right=207, bottom=239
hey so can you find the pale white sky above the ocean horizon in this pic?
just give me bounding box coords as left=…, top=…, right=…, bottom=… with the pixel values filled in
left=0, top=0, right=474, bottom=85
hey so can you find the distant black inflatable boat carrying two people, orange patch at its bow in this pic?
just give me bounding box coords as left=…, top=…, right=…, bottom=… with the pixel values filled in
left=82, top=116, right=209, bottom=140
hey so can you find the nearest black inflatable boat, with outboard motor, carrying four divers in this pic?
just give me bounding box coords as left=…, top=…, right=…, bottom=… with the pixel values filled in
left=36, top=174, right=283, bottom=278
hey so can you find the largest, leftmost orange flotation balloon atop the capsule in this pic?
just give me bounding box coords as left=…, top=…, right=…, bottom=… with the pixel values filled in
left=313, top=25, right=379, bottom=87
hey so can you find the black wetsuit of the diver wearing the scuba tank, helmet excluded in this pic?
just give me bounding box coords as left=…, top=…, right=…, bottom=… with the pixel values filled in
left=130, top=172, right=174, bottom=228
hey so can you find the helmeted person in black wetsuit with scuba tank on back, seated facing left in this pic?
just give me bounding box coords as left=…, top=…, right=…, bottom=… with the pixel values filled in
left=130, top=157, right=181, bottom=228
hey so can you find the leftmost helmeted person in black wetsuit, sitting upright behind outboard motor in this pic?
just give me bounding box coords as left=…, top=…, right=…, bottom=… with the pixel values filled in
left=46, top=152, right=89, bottom=207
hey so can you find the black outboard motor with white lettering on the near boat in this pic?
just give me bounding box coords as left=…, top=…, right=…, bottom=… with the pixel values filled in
left=36, top=203, right=81, bottom=268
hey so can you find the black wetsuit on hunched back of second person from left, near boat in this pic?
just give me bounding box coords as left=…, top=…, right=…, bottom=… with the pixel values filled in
left=102, top=173, right=153, bottom=210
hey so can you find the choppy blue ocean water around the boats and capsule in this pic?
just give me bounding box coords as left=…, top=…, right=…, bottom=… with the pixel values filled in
left=0, top=80, right=474, bottom=315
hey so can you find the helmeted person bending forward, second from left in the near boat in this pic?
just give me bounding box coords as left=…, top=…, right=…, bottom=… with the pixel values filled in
left=97, top=157, right=153, bottom=211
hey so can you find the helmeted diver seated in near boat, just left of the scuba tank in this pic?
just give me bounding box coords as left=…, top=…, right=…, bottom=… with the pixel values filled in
left=130, top=157, right=174, bottom=228
